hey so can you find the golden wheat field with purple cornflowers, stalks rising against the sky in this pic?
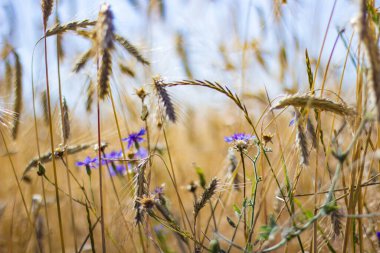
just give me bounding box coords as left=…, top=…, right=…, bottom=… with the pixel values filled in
left=0, top=0, right=380, bottom=253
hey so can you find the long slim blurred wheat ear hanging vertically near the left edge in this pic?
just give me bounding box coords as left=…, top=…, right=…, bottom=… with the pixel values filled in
left=12, top=51, right=22, bottom=139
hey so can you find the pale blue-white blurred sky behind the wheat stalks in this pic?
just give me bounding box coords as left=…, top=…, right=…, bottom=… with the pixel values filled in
left=0, top=0, right=357, bottom=112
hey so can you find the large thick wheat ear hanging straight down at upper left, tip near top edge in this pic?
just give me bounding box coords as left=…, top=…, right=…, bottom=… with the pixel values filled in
left=96, top=4, right=114, bottom=99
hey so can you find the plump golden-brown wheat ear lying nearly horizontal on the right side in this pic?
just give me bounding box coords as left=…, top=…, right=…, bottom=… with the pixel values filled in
left=272, top=94, right=356, bottom=116
